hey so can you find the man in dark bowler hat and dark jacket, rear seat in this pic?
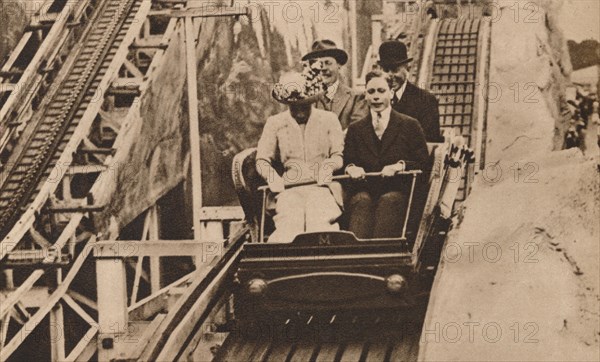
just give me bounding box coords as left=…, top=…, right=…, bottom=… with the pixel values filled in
left=378, top=40, right=444, bottom=142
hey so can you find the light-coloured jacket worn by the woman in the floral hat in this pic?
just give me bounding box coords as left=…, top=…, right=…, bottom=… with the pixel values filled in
left=256, top=107, right=344, bottom=206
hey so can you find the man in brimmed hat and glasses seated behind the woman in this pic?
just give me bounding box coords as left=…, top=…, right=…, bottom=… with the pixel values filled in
left=302, top=39, right=368, bottom=129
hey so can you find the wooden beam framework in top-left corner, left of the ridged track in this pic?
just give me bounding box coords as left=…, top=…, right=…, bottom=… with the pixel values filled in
left=0, top=0, right=99, bottom=156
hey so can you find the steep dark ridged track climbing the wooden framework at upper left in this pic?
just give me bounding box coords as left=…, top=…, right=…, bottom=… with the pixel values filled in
left=0, top=0, right=141, bottom=237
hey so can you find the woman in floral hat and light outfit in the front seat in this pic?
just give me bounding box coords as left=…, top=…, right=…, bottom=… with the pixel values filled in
left=256, top=73, right=344, bottom=243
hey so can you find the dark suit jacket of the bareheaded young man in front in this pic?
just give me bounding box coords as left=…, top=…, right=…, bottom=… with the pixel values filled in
left=344, top=110, right=429, bottom=193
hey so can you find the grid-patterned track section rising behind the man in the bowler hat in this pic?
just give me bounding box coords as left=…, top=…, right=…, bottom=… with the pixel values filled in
left=419, top=18, right=490, bottom=201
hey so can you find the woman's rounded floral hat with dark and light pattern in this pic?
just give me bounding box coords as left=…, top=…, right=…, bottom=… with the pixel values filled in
left=271, top=63, right=327, bottom=105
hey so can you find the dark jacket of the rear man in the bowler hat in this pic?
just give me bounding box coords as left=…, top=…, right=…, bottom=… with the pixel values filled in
left=392, top=82, right=444, bottom=142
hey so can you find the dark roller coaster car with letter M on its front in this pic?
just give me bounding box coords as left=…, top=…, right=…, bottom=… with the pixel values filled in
left=233, top=136, right=462, bottom=320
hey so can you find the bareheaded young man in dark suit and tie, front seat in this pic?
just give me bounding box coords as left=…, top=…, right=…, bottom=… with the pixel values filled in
left=344, top=71, right=429, bottom=239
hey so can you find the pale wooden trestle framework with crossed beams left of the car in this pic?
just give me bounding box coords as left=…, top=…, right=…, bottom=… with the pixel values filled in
left=0, top=0, right=248, bottom=361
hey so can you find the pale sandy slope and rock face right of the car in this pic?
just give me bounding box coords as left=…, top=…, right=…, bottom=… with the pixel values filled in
left=419, top=4, right=600, bottom=361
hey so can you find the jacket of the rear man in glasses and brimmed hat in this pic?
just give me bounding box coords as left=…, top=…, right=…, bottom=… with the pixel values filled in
left=316, top=83, right=369, bottom=129
